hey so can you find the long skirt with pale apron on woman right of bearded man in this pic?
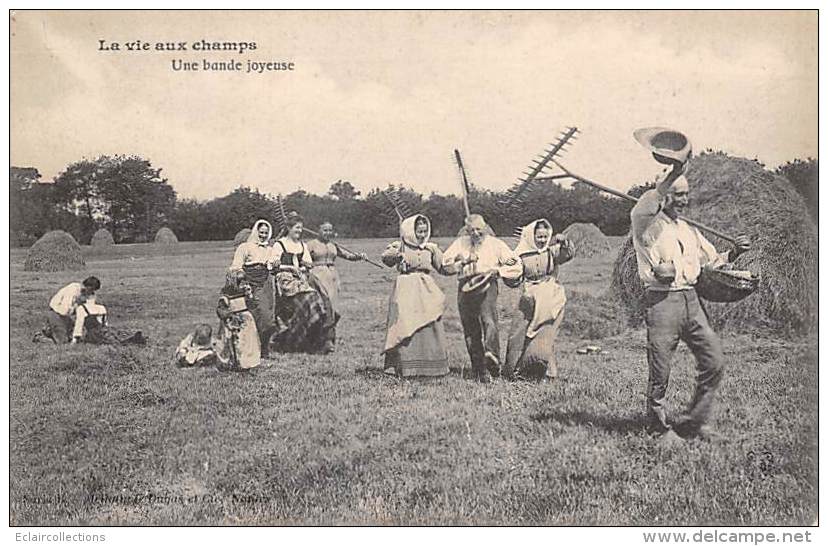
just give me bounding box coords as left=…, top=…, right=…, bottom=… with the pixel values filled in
left=503, top=304, right=564, bottom=379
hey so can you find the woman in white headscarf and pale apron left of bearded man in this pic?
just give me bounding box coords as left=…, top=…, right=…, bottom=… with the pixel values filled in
left=382, top=214, right=448, bottom=377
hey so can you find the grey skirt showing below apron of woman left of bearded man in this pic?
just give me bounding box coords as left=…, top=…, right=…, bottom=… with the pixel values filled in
left=385, top=319, right=448, bottom=377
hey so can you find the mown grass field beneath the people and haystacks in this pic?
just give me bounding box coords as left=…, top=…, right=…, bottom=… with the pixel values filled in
left=9, top=241, right=817, bottom=525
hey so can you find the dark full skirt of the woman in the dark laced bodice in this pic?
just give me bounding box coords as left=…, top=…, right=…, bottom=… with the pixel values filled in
left=270, top=291, right=336, bottom=354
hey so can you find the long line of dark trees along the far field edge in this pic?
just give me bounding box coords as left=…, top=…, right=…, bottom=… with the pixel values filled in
left=10, top=156, right=817, bottom=246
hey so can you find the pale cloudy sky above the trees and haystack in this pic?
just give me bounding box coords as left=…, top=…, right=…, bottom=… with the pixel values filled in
left=10, top=11, right=818, bottom=199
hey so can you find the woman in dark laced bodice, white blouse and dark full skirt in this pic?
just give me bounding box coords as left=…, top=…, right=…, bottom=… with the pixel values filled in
left=272, top=215, right=336, bottom=353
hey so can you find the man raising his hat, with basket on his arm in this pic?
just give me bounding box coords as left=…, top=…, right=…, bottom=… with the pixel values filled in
left=630, top=127, right=750, bottom=440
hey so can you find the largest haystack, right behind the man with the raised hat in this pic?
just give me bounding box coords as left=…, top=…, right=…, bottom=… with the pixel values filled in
left=613, top=153, right=817, bottom=333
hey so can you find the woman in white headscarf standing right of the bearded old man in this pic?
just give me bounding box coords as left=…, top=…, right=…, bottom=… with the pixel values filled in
left=503, top=219, right=575, bottom=381
